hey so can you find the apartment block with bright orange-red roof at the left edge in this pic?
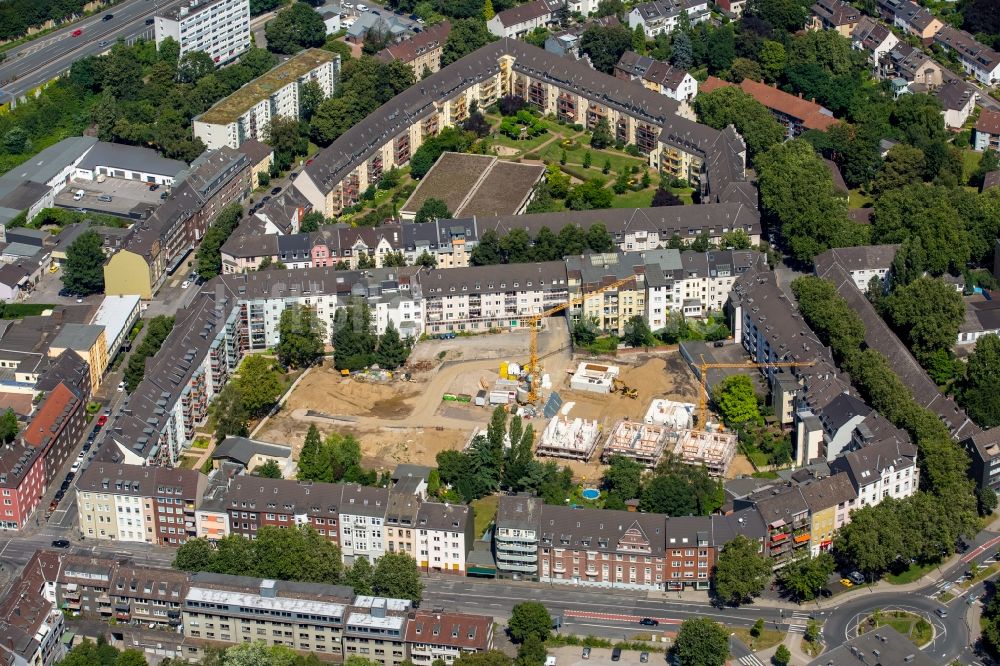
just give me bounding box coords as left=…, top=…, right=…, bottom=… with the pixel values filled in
left=21, top=382, right=86, bottom=487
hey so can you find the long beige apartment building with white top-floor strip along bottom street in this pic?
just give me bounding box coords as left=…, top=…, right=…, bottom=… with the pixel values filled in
left=181, top=574, right=347, bottom=660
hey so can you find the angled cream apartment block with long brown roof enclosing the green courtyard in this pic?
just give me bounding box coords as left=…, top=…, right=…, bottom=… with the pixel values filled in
left=294, top=40, right=745, bottom=217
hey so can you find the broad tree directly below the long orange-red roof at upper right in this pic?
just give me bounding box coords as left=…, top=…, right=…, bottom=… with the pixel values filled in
left=694, top=86, right=785, bottom=161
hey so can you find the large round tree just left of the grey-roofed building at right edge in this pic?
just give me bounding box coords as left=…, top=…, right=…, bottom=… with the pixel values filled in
left=885, top=277, right=965, bottom=362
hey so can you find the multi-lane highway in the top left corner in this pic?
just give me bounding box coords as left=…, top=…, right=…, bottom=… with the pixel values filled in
left=0, top=0, right=184, bottom=103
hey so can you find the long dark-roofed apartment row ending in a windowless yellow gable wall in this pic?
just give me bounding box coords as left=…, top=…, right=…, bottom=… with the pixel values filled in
left=104, top=146, right=251, bottom=300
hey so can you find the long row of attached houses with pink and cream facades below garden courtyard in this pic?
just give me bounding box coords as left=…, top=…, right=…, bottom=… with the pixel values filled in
left=221, top=202, right=760, bottom=275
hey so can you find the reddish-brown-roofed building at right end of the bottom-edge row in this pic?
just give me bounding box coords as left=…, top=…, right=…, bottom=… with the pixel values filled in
left=406, top=610, right=493, bottom=666
